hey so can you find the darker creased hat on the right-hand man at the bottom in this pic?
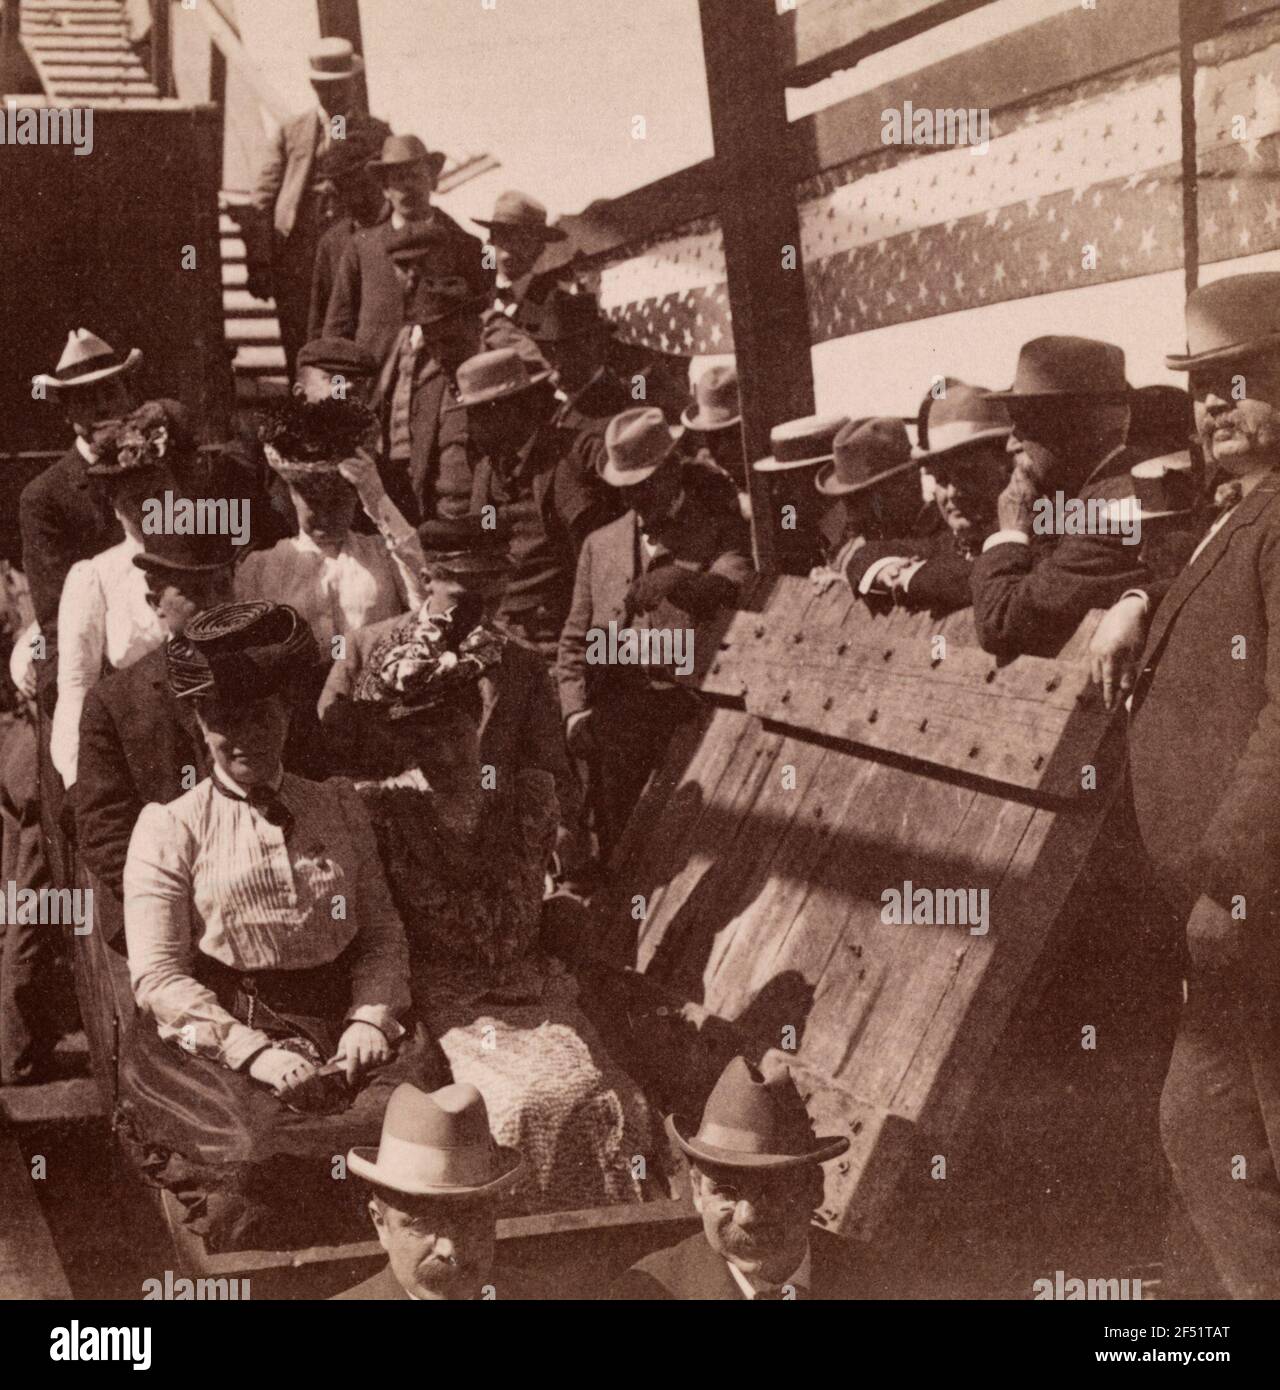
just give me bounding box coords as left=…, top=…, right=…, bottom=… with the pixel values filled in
left=667, top=1056, right=849, bottom=1169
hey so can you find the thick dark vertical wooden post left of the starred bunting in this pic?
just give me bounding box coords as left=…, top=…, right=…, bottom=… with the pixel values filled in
left=699, top=0, right=813, bottom=574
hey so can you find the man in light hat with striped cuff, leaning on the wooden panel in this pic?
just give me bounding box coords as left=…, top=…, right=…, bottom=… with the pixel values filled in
left=819, top=382, right=1013, bottom=617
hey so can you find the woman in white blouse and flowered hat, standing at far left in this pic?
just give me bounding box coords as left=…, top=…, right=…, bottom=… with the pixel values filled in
left=50, top=400, right=179, bottom=787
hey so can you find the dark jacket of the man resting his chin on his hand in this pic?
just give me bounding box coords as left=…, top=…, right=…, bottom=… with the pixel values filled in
left=971, top=449, right=1149, bottom=657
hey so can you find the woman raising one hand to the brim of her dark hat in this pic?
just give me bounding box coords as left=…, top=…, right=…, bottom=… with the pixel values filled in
left=236, top=396, right=427, bottom=647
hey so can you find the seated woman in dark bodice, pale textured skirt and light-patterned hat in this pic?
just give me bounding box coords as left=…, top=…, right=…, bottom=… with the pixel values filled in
left=344, top=613, right=653, bottom=1212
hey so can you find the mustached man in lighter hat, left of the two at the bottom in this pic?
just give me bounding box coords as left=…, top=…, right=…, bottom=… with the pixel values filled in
left=335, top=1081, right=539, bottom=1302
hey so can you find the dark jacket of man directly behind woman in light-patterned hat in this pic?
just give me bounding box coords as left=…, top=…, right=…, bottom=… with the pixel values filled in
left=318, top=616, right=582, bottom=820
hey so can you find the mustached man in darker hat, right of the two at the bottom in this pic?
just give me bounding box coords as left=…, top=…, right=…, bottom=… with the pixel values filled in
left=610, top=1056, right=866, bottom=1302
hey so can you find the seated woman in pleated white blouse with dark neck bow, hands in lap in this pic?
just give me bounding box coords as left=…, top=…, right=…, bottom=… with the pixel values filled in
left=120, top=603, right=441, bottom=1250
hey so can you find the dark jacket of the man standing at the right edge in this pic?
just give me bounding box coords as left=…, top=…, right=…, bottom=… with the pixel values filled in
left=1129, top=474, right=1280, bottom=922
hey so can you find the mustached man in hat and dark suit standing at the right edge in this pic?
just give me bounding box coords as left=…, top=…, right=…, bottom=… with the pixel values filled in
left=1092, top=272, right=1280, bottom=1298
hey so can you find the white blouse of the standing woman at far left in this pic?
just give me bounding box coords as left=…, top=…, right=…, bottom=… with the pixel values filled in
left=50, top=537, right=165, bottom=787
